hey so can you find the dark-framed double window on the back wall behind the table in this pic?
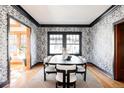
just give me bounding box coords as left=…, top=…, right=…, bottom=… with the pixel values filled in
left=48, top=32, right=81, bottom=55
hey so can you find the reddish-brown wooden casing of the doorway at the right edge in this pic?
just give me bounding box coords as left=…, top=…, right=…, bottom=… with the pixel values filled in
left=113, top=18, right=124, bottom=81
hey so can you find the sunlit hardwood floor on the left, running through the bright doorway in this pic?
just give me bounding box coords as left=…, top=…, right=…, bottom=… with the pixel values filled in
left=5, top=64, right=43, bottom=88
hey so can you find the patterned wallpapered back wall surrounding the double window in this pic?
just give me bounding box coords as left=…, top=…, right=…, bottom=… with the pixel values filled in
left=37, top=27, right=91, bottom=62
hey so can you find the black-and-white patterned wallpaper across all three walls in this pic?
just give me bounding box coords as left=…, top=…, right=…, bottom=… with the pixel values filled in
left=0, top=5, right=124, bottom=84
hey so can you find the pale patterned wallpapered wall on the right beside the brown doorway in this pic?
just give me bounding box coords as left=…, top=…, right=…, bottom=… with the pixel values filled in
left=90, top=6, right=124, bottom=76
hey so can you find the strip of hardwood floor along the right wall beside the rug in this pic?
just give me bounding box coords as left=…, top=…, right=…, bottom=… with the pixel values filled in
left=88, top=65, right=124, bottom=88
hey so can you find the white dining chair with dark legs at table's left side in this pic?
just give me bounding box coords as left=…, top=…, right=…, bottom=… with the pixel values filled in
left=43, top=56, right=56, bottom=81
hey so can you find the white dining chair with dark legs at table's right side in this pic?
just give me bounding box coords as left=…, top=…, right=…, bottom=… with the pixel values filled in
left=76, top=56, right=87, bottom=81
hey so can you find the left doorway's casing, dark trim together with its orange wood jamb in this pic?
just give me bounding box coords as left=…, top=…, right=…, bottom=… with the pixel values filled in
left=7, top=14, right=31, bottom=83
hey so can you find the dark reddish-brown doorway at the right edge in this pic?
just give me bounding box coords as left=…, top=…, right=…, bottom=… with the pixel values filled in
left=114, top=21, right=124, bottom=81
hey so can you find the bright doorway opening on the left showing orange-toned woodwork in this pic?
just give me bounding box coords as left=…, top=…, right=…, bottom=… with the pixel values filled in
left=8, top=16, right=31, bottom=83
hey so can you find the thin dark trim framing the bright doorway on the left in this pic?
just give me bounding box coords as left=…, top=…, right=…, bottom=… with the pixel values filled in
left=7, top=14, right=31, bottom=83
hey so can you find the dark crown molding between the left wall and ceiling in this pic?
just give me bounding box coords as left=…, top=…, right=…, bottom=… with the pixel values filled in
left=11, top=5, right=40, bottom=26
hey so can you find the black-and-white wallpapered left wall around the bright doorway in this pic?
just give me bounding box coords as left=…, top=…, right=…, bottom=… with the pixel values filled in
left=0, top=5, right=38, bottom=84
